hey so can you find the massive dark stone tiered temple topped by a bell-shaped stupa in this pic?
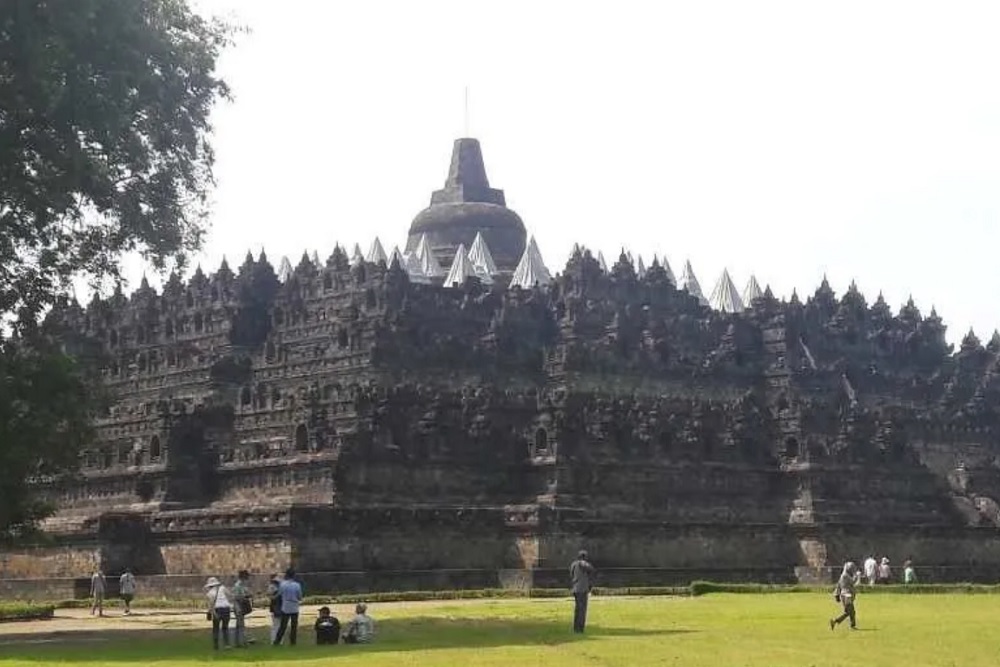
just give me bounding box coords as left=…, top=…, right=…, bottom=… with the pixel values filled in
left=9, top=139, right=1000, bottom=592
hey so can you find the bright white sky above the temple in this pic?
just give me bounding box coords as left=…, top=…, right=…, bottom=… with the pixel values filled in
left=136, top=0, right=1000, bottom=341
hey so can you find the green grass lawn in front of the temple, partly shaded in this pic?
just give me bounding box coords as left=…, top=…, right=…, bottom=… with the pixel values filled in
left=0, top=593, right=1000, bottom=667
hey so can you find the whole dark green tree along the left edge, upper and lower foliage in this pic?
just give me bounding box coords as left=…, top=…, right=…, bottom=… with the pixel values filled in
left=0, top=0, right=233, bottom=536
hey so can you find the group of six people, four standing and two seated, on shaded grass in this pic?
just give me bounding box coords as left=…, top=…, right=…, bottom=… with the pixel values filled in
left=205, top=568, right=375, bottom=650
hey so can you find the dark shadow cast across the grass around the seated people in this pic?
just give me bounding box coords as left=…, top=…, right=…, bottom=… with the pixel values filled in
left=0, top=617, right=693, bottom=664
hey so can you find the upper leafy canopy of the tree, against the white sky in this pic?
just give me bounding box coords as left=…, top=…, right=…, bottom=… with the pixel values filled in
left=0, top=0, right=231, bottom=321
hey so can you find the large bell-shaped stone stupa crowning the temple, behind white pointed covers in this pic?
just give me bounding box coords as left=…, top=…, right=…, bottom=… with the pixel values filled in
left=406, top=138, right=526, bottom=274
